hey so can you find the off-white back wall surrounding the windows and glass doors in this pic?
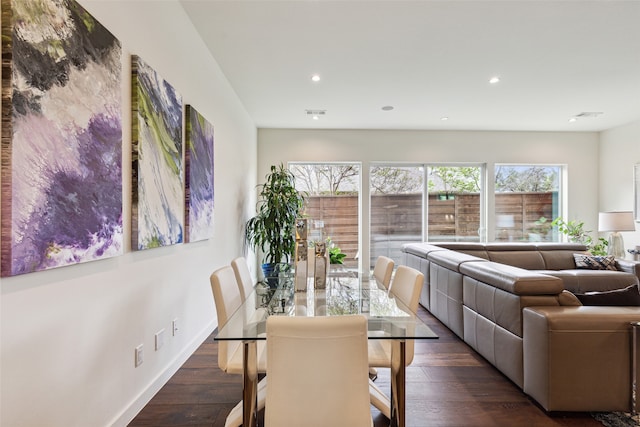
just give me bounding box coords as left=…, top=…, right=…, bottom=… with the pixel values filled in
left=258, top=129, right=599, bottom=270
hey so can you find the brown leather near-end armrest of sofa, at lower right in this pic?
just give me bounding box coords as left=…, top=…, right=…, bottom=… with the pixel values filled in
left=522, top=306, right=640, bottom=411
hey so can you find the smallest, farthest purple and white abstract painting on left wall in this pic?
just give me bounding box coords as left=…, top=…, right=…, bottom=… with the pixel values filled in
left=185, top=105, right=213, bottom=242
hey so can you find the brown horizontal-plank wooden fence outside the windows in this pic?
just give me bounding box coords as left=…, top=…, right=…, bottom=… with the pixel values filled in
left=307, top=193, right=557, bottom=267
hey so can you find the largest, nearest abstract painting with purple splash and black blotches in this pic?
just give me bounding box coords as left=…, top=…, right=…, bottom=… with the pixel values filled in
left=0, top=0, right=123, bottom=276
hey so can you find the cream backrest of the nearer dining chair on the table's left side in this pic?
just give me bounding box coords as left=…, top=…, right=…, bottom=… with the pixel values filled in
left=209, top=266, right=242, bottom=372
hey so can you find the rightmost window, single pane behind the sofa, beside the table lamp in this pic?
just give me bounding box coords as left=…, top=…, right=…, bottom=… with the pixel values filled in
left=495, top=164, right=562, bottom=241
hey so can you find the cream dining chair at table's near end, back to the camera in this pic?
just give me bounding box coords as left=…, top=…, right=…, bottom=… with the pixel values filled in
left=264, top=315, right=373, bottom=427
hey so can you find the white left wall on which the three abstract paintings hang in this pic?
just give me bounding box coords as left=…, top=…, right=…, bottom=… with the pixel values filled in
left=0, top=0, right=256, bottom=427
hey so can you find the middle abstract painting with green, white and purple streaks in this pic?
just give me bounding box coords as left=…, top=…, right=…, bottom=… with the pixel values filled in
left=131, top=56, right=184, bottom=250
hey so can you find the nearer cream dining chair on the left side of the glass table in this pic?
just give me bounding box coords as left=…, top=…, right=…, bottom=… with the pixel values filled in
left=210, top=266, right=267, bottom=427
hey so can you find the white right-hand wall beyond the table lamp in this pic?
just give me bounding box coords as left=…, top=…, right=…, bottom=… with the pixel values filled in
left=599, top=121, right=640, bottom=259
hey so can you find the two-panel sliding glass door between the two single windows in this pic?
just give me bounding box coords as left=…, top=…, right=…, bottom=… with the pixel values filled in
left=370, top=164, right=484, bottom=268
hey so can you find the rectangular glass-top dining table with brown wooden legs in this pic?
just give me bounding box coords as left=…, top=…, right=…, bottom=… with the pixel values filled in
left=214, top=274, right=438, bottom=427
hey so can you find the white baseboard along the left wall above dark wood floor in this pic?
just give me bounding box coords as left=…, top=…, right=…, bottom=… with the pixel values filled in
left=109, top=322, right=217, bottom=427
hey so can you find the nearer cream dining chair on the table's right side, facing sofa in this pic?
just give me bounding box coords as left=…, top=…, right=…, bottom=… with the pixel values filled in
left=368, top=265, right=424, bottom=418
